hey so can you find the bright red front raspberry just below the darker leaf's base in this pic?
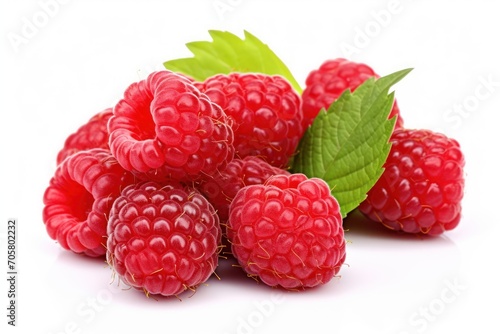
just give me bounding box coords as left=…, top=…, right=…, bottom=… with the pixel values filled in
left=227, top=174, right=346, bottom=289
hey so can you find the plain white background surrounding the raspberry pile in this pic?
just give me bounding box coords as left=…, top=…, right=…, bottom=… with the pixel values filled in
left=0, top=0, right=500, bottom=334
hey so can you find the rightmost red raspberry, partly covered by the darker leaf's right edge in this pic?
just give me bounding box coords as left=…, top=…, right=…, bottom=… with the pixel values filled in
left=359, top=129, right=465, bottom=235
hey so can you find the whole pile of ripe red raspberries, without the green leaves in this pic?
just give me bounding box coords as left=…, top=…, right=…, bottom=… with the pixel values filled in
left=43, top=59, right=464, bottom=296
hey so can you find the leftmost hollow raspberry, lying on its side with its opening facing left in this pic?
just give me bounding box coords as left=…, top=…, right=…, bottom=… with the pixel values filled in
left=43, top=148, right=134, bottom=257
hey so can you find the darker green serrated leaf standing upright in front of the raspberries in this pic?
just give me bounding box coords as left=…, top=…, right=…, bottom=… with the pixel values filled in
left=293, top=69, right=411, bottom=217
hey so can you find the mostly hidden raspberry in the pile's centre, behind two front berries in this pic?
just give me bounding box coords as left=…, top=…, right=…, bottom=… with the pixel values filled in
left=200, top=156, right=289, bottom=224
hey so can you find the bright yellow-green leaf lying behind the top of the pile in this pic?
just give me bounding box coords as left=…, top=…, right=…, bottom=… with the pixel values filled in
left=163, top=30, right=302, bottom=94
